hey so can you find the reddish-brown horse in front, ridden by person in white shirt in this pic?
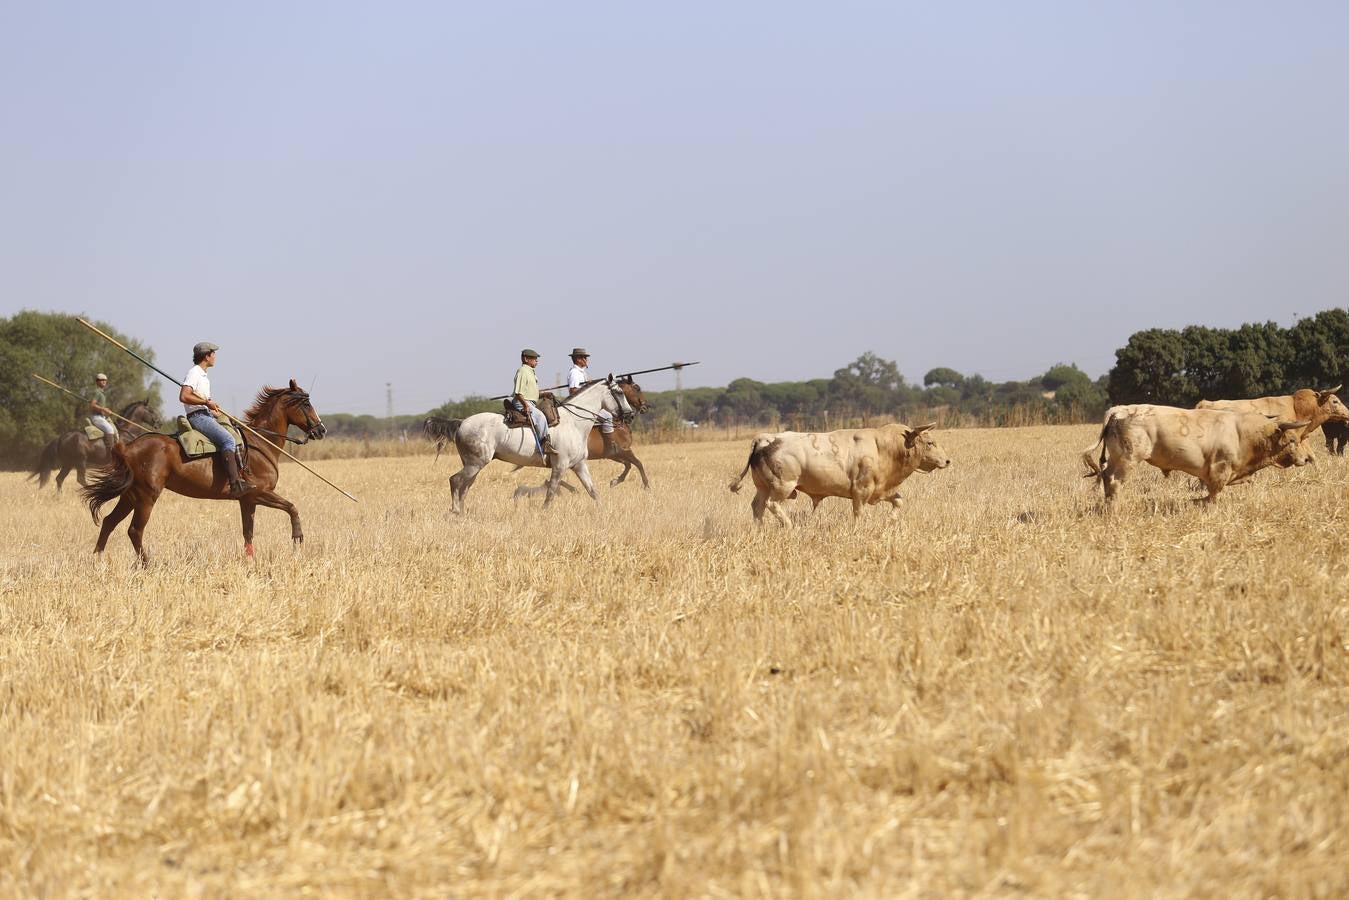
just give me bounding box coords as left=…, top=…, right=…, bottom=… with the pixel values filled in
left=81, top=379, right=328, bottom=564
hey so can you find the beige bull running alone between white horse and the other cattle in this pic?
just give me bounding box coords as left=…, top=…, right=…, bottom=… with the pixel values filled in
left=730, top=422, right=951, bottom=528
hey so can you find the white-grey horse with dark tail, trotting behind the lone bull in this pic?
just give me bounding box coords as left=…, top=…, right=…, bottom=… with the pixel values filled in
left=449, top=375, right=633, bottom=513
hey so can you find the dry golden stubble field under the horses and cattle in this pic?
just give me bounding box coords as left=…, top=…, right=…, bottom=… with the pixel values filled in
left=0, top=426, right=1349, bottom=897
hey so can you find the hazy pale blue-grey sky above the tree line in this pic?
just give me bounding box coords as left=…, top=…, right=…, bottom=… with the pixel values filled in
left=0, top=0, right=1349, bottom=414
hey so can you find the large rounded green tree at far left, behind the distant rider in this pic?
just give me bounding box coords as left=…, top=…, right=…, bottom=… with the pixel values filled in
left=0, top=310, right=161, bottom=467
